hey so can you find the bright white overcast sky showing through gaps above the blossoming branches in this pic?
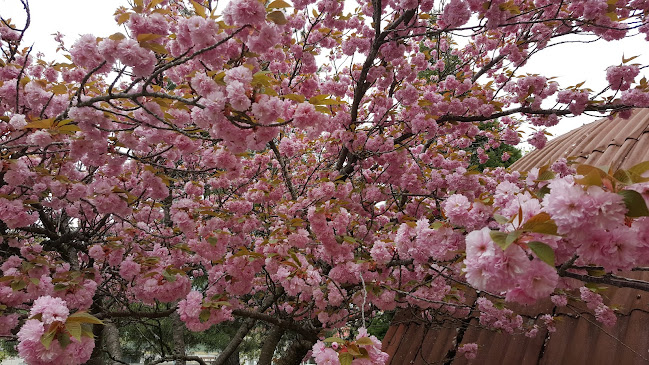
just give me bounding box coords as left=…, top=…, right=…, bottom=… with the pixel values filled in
left=0, top=0, right=649, bottom=145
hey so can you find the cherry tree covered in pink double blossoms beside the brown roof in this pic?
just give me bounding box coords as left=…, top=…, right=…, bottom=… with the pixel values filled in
left=0, top=0, right=649, bottom=364
